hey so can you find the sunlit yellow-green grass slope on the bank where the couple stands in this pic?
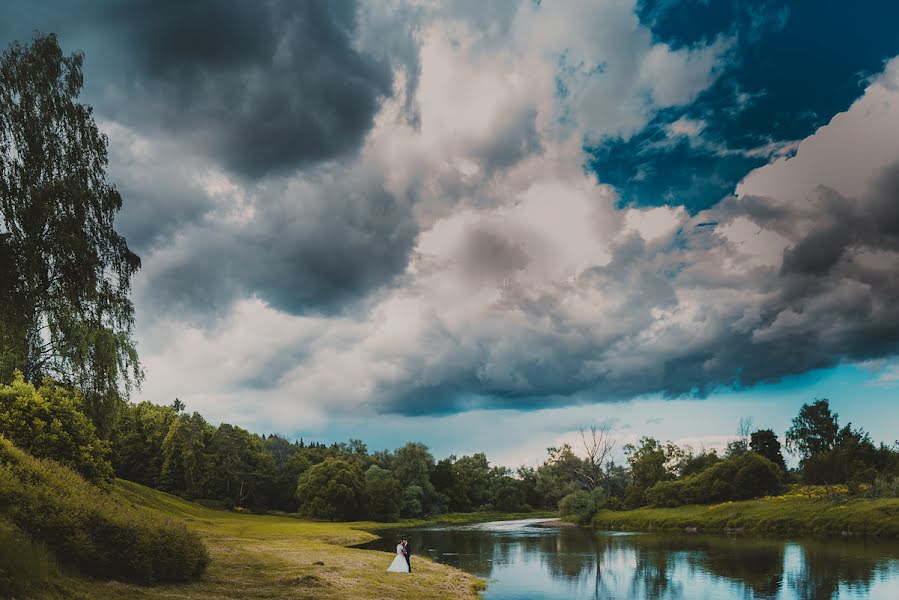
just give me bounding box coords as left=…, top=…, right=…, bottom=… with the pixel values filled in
left=57, top=480, right=483, bottom=600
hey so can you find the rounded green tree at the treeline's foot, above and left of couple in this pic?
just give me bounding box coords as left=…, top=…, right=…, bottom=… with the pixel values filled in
left=297, top=458, right=363, bottom=521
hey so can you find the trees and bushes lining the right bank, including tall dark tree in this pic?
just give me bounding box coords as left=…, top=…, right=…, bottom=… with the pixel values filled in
left=550, top=399, right=899, bottom=523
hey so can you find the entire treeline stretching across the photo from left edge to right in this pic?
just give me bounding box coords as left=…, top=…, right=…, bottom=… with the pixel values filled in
left=0, top=375, right=899, bottom=521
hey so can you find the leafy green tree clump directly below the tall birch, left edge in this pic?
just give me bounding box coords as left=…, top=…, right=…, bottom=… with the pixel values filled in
left=0, top=372, right=112, bottom=482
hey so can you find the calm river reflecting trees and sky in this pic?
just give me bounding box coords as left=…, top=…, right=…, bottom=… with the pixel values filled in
left=363, top=520, right=899, bottom=600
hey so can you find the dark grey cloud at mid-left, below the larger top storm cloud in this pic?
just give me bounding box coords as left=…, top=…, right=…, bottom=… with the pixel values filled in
left=140, top=167, right=418, bottom=324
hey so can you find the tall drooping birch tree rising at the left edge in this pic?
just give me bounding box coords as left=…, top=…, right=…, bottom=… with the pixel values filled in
left=0, top=34, right=141, bottom=434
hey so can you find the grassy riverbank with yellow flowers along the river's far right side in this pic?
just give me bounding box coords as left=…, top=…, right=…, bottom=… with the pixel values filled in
left=592, top=488, right=899, bottom=540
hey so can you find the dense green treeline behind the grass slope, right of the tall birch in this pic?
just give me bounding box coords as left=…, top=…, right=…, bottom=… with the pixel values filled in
left=110, top=401, right=558, bottom=521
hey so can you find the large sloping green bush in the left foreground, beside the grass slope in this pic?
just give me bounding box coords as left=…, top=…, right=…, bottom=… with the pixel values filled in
left=0, top=436, right=209, bottom=583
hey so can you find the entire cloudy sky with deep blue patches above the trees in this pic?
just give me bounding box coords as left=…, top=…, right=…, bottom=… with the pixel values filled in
left=0, top=0, right=899, bottom=466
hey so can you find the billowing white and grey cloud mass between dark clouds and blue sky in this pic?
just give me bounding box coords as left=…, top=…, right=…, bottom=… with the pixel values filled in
left=126, top=2, right=899, bottom=443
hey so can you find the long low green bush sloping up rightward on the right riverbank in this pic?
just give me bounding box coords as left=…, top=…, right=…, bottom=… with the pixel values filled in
left=646, top=452, right=782, bottom=506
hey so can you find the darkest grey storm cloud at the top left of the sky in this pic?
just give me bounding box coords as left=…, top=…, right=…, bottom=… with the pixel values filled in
left=0, top=0, right=393, bottom=178
